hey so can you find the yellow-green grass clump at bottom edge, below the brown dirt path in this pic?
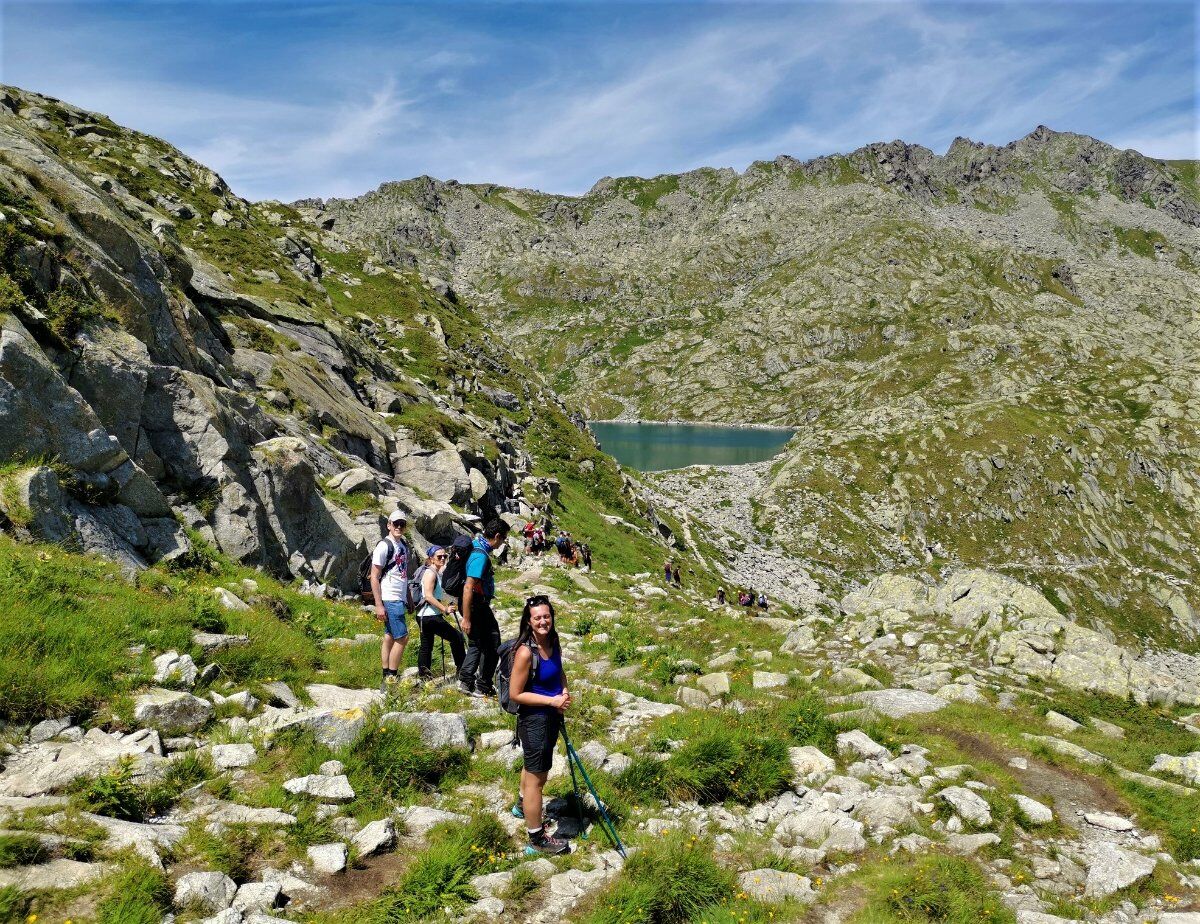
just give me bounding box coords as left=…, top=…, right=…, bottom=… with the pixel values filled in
left=851, top=853, right=1015, bottom=924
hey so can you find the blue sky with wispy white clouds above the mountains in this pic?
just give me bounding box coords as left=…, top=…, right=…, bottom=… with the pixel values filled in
left=0, top=0, right=1200, bottom=200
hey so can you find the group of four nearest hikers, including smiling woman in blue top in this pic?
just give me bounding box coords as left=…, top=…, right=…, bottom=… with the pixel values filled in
left=364, top=510, right=571, bottom=854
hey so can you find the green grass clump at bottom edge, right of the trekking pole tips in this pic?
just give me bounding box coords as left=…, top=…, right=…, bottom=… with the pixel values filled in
left=584, top=833, right=734, bottom=924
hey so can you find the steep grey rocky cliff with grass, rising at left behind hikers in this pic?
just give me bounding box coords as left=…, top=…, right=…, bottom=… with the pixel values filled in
left=0, top=89, right=648, bottom=589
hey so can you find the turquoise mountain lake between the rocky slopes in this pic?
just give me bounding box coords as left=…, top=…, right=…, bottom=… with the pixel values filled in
left=588, top=422, right=796, bottom=472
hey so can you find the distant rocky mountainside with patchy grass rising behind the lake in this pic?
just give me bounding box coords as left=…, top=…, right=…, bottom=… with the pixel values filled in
left=312, top=127, right=1200, bottom=649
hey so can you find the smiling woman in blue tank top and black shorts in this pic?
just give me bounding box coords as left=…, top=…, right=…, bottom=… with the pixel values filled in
left=509, top=594, right=571, bottom=854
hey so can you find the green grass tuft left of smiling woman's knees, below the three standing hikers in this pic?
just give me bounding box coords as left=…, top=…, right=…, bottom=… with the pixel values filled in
left=341, top=725, right=470, bottom=799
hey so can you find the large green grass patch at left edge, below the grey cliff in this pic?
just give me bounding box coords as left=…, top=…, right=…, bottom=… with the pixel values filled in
left=0, top=536, right=373, bottom=722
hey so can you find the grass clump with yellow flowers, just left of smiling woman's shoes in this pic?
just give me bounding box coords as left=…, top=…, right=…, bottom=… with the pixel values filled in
left=366, top=815, right=512, bottom=924
